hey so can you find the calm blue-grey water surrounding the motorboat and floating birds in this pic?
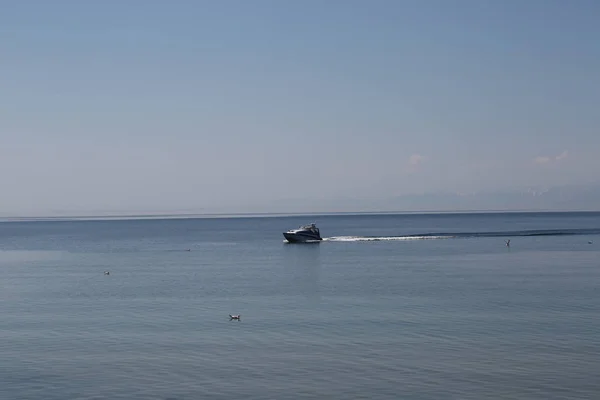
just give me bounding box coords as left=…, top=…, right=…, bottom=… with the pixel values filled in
left=0, top=213, right=600, bottom=400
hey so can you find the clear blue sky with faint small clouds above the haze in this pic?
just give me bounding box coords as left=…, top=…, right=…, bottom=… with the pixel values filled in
left=0, top=0, right=600, bottom=215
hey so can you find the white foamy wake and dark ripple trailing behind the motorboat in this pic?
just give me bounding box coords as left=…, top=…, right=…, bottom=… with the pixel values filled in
left=323, top=228, right=600, bottom=242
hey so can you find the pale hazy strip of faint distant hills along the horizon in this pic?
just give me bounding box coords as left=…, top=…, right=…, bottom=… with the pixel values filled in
left=0, top=185, right=600, bottom=219
